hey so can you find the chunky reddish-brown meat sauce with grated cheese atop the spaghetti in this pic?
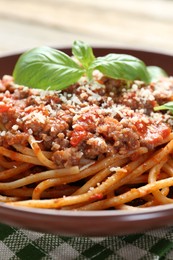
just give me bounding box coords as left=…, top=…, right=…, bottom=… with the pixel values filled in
left=0, top=76, right=173, bottom=167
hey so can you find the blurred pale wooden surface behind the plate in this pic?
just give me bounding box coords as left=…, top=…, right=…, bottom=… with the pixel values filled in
left=0, top=0, right=173, bottom=56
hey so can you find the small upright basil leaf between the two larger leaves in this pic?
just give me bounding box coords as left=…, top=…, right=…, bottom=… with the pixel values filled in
left=72, top=41, right=95, bottom=69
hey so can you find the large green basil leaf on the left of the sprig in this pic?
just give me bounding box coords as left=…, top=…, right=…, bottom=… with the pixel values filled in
left=13, top=46, right=84, bottom=90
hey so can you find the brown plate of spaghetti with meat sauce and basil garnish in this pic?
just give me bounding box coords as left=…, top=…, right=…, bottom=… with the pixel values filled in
left=0, top=41, right=173, bottom=236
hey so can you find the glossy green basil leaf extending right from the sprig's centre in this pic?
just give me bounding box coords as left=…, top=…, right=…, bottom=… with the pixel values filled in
left=90, top=53, right=150, bottom=83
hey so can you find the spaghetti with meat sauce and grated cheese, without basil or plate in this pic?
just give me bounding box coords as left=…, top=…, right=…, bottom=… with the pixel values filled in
left=0, top=72, right=173, bottom=210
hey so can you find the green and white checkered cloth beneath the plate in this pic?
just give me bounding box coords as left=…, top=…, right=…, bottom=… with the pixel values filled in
left=0, top=224, right=173, bottom=260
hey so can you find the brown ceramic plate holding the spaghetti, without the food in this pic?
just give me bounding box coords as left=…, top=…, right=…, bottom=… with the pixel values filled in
left=0, top=48, right=173, bottom=236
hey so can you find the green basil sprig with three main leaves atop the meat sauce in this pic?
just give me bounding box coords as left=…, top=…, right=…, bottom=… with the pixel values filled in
left=13, top=41, right=168, bottom=90
